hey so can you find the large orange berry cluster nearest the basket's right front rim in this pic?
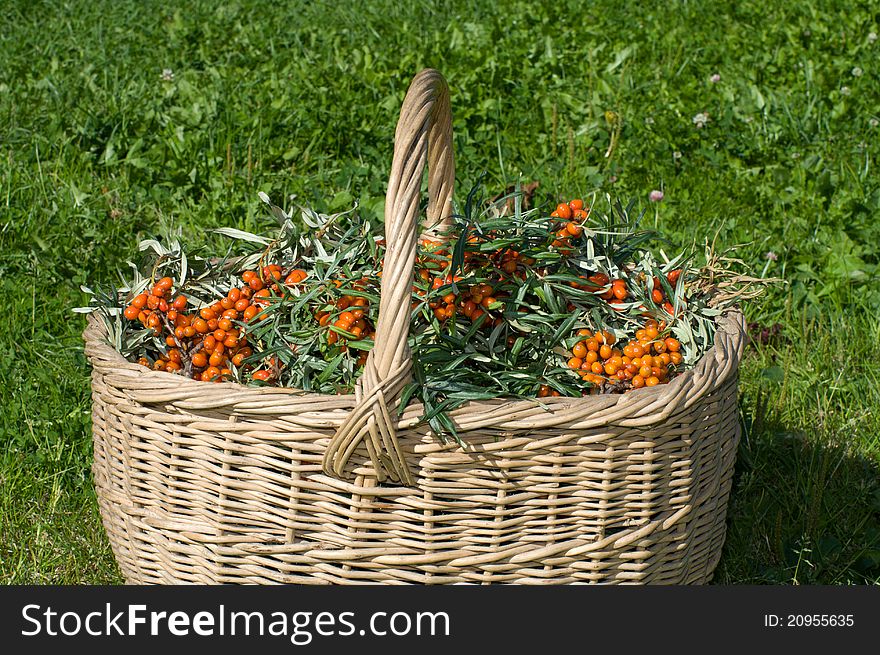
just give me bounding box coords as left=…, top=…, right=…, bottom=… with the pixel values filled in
left=556, top=320, right=682, bottom=389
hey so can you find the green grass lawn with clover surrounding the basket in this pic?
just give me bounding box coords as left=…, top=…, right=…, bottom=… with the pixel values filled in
left=0, top=0, right=880, bottom=584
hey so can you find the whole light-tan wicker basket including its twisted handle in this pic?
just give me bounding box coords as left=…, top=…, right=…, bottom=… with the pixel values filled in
left=84, top=70, right=744, bottom=584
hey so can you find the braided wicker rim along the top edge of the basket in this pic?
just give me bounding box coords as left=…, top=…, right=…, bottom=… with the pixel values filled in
left=83, top=307, right=746, bottom=431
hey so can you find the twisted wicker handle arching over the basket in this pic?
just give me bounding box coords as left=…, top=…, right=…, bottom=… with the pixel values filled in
left=323, top=68, right=455, bottom=486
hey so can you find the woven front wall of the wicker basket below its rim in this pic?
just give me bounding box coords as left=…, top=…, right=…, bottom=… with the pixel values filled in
left=92, top=312, right=739, bottom=584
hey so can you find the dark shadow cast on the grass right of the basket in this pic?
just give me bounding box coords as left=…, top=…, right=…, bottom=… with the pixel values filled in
left=714, top=392, right=880, bottom=584
